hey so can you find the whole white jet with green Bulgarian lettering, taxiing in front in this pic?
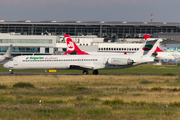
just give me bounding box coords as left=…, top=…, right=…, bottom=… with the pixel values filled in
left=3, top=38, right=162, bottom=75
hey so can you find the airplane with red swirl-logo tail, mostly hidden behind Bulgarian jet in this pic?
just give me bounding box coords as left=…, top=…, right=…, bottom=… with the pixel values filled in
left=64, top=34, right=130, bottom=55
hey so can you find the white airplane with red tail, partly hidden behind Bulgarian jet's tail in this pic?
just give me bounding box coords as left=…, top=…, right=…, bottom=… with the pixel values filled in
left=144, top=35, right=180, bottom=64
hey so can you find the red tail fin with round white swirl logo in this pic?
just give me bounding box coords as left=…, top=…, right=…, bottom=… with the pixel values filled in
left=64, top=35, right=89, bottom=55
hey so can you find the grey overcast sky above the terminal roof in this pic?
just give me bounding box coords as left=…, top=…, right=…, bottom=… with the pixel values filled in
left=0, top=0, right=180, bottom=23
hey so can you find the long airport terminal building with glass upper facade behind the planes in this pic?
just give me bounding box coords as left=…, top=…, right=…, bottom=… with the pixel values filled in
left=0, top=20, right=180, bottom=54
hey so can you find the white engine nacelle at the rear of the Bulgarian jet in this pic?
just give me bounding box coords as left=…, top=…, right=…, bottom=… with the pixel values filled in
left=108, top=58, right=134, bottom=65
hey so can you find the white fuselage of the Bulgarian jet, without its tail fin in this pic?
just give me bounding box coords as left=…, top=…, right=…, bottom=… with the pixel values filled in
left=4, top=54, right=149, bottom=70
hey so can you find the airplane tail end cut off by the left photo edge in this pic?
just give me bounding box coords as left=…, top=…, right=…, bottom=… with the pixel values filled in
left=0, top=45, right=12, bottom=62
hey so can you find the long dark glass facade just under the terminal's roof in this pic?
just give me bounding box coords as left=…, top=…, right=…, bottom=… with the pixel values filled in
left=0, top=22, right=180, bottom=40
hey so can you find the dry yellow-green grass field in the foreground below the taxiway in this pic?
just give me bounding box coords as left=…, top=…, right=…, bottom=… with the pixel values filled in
left=0, top=75, right=180, bottom=120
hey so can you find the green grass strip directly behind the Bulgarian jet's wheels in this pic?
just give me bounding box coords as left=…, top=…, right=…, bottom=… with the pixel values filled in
left=0, top=64, right=180, bottom=75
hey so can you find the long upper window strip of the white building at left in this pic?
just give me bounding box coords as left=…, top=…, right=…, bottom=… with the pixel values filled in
left=0, top=39, right=52, bottom=44
